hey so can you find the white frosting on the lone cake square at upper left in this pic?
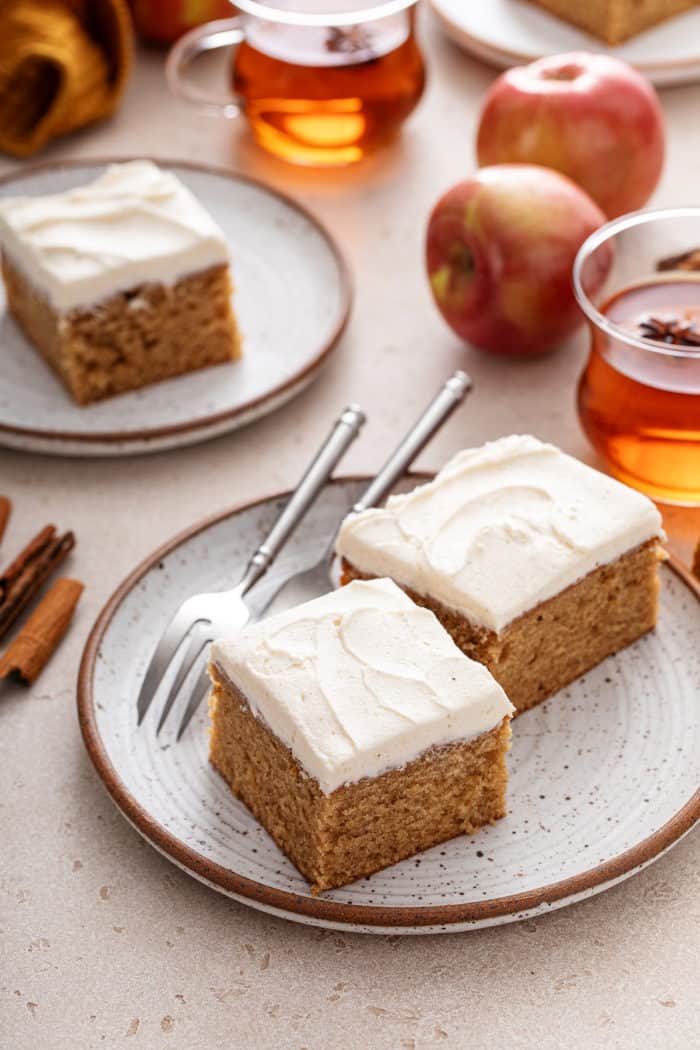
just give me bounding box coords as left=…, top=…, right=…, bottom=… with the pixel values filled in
left=0, top=161, right=229, bottom=312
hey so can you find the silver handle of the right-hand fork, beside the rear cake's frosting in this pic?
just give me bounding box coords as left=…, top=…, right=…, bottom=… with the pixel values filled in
left=349, top=372, right=471, bottom=513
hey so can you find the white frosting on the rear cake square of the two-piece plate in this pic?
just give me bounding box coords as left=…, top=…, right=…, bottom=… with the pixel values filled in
left=336, top=435, right=663, bottom=631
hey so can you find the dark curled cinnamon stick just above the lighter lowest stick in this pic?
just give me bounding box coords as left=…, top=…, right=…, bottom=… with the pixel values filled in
left=0, top=525, right=76, bottom=638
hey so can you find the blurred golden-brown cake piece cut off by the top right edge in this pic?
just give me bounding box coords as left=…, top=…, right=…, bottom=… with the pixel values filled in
left=530, top=0, right=700, bottom=44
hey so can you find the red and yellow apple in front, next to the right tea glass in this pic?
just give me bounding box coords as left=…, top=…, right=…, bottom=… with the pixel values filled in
left=426, top=164, right=610, bottom=355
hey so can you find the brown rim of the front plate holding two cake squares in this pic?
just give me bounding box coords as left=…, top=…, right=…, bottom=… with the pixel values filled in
left=78, top=473, right=700, bottom=928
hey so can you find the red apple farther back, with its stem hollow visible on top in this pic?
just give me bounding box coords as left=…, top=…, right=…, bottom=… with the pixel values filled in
left=476, top=51, right=664, bottom=218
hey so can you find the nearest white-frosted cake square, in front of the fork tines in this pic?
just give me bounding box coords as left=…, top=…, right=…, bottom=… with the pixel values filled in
left=210, top=580, right=512, bottom=893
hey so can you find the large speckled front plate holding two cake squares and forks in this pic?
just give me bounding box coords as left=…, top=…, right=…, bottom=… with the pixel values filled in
left=79, top=480, right=700, bottom=933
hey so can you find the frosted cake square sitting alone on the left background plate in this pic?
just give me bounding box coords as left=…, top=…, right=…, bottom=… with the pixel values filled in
left=0, top=161, right=240, bottom=404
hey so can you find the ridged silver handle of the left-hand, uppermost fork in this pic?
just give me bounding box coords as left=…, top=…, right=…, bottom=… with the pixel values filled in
left=239, top=404, right=366, bottom=594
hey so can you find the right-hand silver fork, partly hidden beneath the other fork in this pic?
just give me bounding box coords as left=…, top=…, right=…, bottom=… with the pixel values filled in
left=177, top=372, right=471, bottom=740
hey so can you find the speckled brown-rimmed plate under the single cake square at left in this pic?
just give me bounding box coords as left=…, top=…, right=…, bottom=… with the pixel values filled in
left=0, top=158, right=352, bottom=456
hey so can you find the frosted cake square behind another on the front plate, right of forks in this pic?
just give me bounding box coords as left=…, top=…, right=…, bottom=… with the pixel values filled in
left=337, top=436, right=663, bottom=713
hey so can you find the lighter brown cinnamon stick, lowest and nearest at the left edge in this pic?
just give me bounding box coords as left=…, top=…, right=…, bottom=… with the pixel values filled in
left=0, top=576, right=84, bottom=686
